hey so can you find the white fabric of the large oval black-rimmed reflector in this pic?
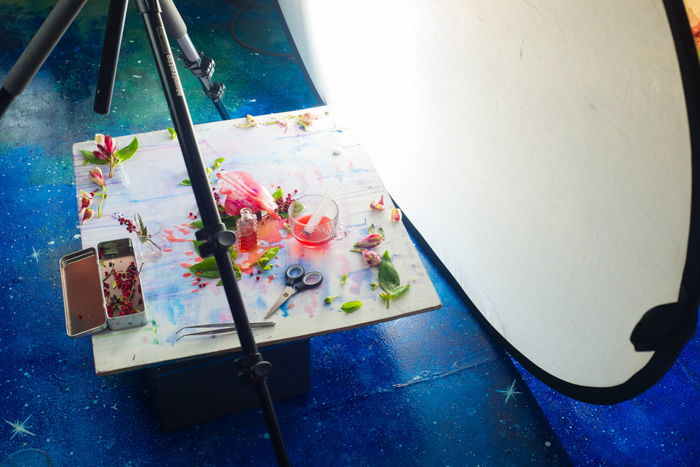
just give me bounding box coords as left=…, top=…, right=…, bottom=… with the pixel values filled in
left=280, top=0, right=691, bottom=387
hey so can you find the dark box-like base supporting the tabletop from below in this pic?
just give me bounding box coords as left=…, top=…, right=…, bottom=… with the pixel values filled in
left=146, top=339, right=311, bottom=431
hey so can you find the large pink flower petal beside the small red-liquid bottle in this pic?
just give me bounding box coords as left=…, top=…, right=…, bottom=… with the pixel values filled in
left=216, top=170, right=280, bottom=219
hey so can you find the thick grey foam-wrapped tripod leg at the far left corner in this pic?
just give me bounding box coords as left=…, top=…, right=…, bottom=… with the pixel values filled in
left=0, top=0, right=87, bottom=118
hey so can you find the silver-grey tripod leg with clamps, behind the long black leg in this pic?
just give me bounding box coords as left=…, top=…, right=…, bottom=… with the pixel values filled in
left=160, top=0, right=231, bottom=120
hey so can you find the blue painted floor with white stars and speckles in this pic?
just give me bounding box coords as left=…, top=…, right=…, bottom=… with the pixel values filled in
left=0, top=0, right=700, bottom=466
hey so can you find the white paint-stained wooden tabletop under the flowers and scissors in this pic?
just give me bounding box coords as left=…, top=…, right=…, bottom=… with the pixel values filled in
left=73, top=107, right=440, bottom=375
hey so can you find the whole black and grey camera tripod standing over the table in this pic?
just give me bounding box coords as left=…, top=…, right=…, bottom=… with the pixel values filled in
left=0, top=0, right=289, bottom=465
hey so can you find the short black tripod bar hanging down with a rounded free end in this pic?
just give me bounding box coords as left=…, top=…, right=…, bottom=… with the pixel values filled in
left=93, top=0, right=129, bottom=115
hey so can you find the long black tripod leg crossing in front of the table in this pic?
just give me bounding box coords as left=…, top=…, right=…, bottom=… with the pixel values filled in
left=136, top=0, right=289, bottom=465
